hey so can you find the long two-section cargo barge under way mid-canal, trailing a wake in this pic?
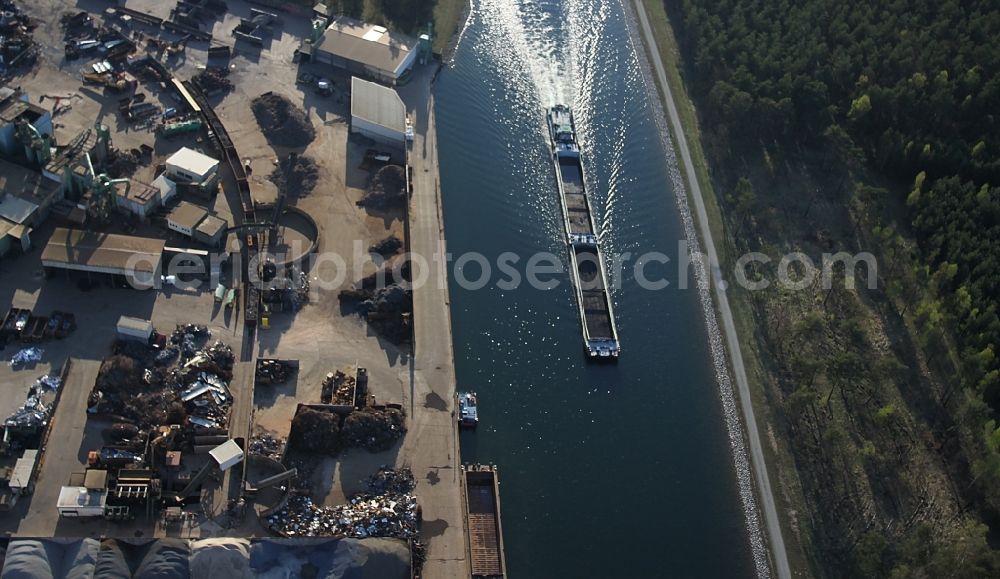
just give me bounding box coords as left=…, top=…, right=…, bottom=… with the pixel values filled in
left=548, top=105, right=620, bottom=360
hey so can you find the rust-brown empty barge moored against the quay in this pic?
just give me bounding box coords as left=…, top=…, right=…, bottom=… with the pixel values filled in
left=462, top=464, right=507, bottom=579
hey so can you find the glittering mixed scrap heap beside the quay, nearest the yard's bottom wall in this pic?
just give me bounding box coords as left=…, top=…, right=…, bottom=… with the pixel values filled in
left=265, top=467, right=420, bottom=539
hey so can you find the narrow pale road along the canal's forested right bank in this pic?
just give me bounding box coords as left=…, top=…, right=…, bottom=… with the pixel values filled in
left=632, top=0, right=792, bottom=579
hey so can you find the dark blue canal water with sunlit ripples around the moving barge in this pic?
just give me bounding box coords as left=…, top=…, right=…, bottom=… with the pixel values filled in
left=435, top=0, right=754, bottom=578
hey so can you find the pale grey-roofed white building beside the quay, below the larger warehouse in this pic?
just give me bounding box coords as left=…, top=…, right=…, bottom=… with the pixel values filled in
left=351, top=76, right=406, bottom=149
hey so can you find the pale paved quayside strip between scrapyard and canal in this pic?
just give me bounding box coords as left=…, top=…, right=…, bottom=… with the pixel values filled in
left=399, top=65, right=470, bottom=579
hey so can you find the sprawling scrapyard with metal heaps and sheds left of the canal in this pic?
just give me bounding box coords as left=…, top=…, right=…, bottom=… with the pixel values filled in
left=0, top=0, right=480, bottom=577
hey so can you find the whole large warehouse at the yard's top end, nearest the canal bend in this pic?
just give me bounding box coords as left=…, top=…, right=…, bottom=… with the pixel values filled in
left=311, top=16, right=419, bottom=85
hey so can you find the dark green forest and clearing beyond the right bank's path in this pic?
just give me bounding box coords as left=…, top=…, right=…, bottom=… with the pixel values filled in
left=664, top=0, right=1000, bottom=577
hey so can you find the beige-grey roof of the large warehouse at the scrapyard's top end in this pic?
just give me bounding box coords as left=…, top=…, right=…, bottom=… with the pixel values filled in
left=317, top=16, right=417, bottom=73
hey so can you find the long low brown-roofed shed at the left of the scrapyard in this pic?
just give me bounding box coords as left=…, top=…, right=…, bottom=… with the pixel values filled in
left=42, top=227, right=166, bottom=288
